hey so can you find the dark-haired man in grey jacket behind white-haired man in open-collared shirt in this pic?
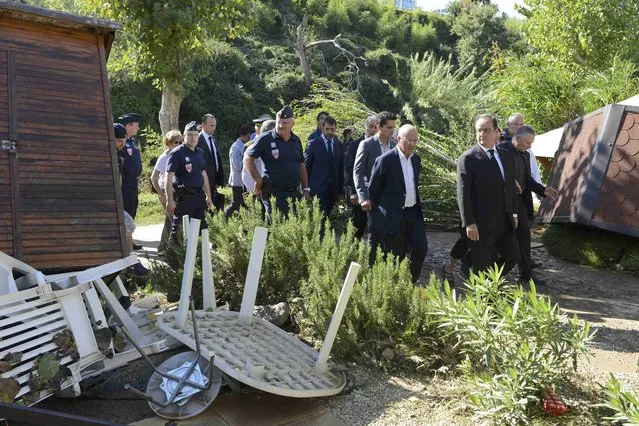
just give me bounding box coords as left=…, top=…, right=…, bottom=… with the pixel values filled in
left=353, top=111, right=397, bottom=265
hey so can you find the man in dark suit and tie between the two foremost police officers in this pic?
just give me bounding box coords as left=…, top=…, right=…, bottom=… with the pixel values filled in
left=197, top=114, right=224, bottom=210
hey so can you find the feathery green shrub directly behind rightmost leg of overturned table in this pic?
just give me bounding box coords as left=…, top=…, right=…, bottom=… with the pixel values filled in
left=300, top=233, right=415, bottom=359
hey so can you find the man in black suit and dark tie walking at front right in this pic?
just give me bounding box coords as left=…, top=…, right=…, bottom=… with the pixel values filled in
left=457, top=115, right=519, bottom=275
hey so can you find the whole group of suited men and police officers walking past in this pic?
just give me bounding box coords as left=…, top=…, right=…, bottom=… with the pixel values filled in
left=114, top=106, right=557, bottom=283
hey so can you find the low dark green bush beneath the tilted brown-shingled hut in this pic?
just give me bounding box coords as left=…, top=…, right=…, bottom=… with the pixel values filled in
left=542, top=224, right=639, bottom=271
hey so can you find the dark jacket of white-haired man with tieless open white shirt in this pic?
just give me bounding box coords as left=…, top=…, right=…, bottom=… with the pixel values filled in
left=368, top=148, right=423, bottom=234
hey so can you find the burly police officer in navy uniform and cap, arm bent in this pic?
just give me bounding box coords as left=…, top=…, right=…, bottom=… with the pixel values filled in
left=244, top=106, right=310, bottom=223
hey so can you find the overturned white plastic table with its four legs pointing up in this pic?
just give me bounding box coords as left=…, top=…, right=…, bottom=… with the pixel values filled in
left=157, top=219, right=360, bottom=398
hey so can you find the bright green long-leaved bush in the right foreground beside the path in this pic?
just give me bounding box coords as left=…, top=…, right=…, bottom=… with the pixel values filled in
left=425, top=267, right=594, bottom=424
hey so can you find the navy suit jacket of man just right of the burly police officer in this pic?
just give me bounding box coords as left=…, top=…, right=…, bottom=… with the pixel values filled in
left=304, top=136, right=344, bottom=198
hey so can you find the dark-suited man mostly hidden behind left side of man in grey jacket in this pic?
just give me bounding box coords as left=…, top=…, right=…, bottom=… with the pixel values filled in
left=344, top=115, right=377, bottom=238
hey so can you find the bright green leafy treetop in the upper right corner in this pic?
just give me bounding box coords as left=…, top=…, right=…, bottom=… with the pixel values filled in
left=520, top=0, right=639, bottom=70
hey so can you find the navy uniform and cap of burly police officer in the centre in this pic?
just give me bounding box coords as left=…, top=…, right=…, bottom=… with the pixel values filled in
left=248, top=107, right=304, bottom=218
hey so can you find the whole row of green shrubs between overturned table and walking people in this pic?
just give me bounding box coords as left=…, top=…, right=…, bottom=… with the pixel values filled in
left=153, top=201, right=592, bottom=424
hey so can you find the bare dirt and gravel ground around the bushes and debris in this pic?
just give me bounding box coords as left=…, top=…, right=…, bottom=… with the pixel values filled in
left=41, top=232, right=639, bottom=425
